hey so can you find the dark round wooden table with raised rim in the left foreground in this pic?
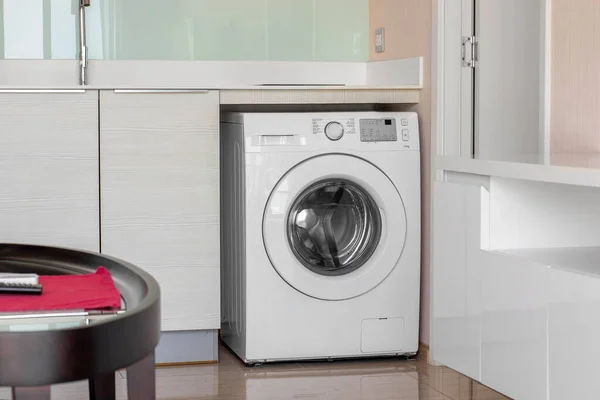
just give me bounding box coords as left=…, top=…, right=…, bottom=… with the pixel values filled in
left=0, top=244, right=160, bottom=400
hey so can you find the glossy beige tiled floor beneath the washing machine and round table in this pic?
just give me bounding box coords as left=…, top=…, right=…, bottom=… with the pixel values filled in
left=0, top=349, right=506, bottom=400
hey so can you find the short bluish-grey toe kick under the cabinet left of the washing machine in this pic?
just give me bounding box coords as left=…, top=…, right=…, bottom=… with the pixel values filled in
left=155, top=330, right=219, bottom=366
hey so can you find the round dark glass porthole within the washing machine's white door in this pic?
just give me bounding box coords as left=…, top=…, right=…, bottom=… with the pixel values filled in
left=287, top=179, right=381, bottom=275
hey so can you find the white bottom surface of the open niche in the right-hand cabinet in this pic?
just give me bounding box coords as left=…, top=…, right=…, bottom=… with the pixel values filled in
left=493, top=246, right=600, bottom=278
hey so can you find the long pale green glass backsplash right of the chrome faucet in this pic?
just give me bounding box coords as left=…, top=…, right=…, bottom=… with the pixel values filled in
left=86, top=0, right=369, bottom=61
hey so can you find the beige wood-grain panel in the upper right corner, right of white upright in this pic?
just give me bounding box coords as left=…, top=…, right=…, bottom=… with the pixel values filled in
left=550, top=0, right=600, bottom=168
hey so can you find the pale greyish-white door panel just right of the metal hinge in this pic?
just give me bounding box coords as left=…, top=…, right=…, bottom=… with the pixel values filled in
left=474, top=0, right=549, bottom=163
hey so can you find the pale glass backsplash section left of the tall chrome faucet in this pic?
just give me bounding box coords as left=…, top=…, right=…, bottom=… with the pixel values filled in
left=0, top=0, right=78, bottom=60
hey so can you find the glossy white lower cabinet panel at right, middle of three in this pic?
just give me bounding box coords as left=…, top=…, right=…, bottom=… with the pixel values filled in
left=480, top=252, right=548, bottom=400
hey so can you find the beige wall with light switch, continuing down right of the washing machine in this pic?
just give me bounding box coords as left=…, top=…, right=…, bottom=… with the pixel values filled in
left=369, top=0, right=434, bottom=344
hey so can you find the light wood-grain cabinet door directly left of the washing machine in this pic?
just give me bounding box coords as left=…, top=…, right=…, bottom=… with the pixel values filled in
left=100, top=91, right=220, bottom=331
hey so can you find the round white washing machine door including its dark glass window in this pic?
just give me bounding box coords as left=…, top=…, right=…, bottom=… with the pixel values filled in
left=263, top=154, right=406, bottom=300
